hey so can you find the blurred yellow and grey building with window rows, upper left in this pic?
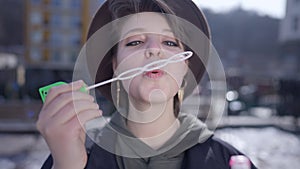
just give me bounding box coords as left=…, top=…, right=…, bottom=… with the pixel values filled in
left=25, top=0, right=103, bottom=69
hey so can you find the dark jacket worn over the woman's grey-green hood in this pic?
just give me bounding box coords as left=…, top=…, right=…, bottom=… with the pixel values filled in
left=42, top=137, right=256, bottom=169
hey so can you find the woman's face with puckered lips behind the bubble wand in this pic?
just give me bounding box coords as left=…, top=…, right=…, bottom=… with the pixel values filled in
left=114, top=12, right=188, bottom=105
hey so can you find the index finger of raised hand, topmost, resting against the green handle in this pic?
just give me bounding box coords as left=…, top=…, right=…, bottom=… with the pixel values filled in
left=44, top=80, right=85, bottom=106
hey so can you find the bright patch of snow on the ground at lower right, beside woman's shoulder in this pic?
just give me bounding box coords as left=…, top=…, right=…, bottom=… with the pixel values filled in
left=216, top=127, right=300, bottom=169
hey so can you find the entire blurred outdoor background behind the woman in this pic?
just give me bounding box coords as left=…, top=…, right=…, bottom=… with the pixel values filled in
left=0, top=0, right=300, bottom=169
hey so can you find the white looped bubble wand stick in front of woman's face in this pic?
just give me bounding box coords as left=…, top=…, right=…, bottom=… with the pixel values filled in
left=85, top=51, right=193, bottom=90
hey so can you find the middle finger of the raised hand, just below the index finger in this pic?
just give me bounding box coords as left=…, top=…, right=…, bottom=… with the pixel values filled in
left=43, top=91, right=94, bottom=118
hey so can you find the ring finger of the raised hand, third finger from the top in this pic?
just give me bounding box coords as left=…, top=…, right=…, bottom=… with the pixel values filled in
left=52, top=100, right=99, bottom=124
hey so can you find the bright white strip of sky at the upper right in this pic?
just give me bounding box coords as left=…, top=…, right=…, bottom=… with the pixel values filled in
left=194, top=0, right=287, bottom=18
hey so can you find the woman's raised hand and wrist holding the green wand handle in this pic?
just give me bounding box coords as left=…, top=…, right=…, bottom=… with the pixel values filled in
left=37, top=81, right=102, bottom=169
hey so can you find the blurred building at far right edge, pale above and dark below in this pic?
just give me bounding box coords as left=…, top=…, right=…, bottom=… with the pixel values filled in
left=278, top=0, right=300, bottom=117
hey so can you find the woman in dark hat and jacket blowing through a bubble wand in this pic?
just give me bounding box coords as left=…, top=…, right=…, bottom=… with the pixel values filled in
left=37, top=0, right=255, bottom=169
